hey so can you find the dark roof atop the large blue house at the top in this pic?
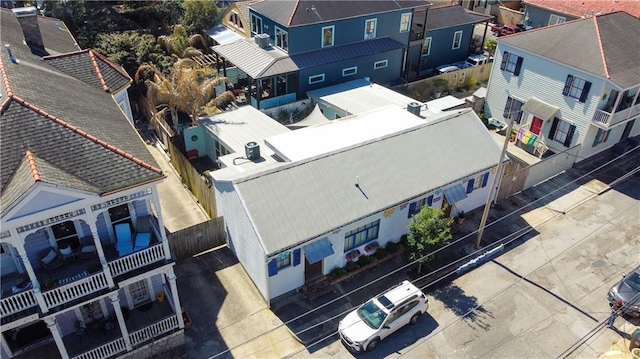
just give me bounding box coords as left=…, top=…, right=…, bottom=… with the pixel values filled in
left=250, top=0, right=429, bottom=27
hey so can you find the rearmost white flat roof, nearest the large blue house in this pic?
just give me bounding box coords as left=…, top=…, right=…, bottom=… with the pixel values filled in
left=307, top=78, right=418, bottom=115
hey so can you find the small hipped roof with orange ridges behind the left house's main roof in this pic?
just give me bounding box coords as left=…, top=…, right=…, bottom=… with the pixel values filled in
left=43, top=50, right=131, bottom=93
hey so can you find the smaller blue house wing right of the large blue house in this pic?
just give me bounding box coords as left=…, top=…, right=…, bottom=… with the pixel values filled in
left=409, top=5, right=492, bottom=79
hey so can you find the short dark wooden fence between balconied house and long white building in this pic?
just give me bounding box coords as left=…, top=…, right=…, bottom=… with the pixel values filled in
left=167, top=217, right=227, bottom=261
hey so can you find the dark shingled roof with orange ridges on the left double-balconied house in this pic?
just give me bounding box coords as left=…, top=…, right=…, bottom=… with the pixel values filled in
left=0, top=10, right=163, bottom=213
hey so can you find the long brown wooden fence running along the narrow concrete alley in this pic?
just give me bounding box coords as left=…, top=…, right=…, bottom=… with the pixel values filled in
left=169, top=141, right=218, bottom=218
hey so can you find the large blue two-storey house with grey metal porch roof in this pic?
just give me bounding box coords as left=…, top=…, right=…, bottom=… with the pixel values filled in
left=213, top=0, right=429, bottom=109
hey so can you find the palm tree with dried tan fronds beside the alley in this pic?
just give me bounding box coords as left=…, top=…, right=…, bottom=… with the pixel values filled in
left=134, top=59, right=235, bottom=132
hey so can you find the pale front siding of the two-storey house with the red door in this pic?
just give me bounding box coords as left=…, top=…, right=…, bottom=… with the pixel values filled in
left=486, top=43, right=604, bottom=156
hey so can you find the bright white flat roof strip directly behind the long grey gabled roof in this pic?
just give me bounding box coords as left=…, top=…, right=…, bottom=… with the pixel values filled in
left=264, top=106, right=425, bottom=162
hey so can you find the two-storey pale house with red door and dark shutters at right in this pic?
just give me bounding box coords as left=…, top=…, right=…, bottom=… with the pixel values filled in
left=485, top=12, right=640, bottom=162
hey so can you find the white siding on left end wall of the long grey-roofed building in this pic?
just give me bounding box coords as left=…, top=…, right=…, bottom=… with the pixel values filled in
left=215, top=182, right=270, bottom=300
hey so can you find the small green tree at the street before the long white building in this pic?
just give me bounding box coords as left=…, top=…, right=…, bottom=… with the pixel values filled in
left=406, top=206, right=453, bottom=274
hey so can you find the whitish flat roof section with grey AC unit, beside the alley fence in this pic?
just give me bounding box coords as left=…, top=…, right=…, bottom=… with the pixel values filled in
left=198, top=106, right=291, bottom=173
